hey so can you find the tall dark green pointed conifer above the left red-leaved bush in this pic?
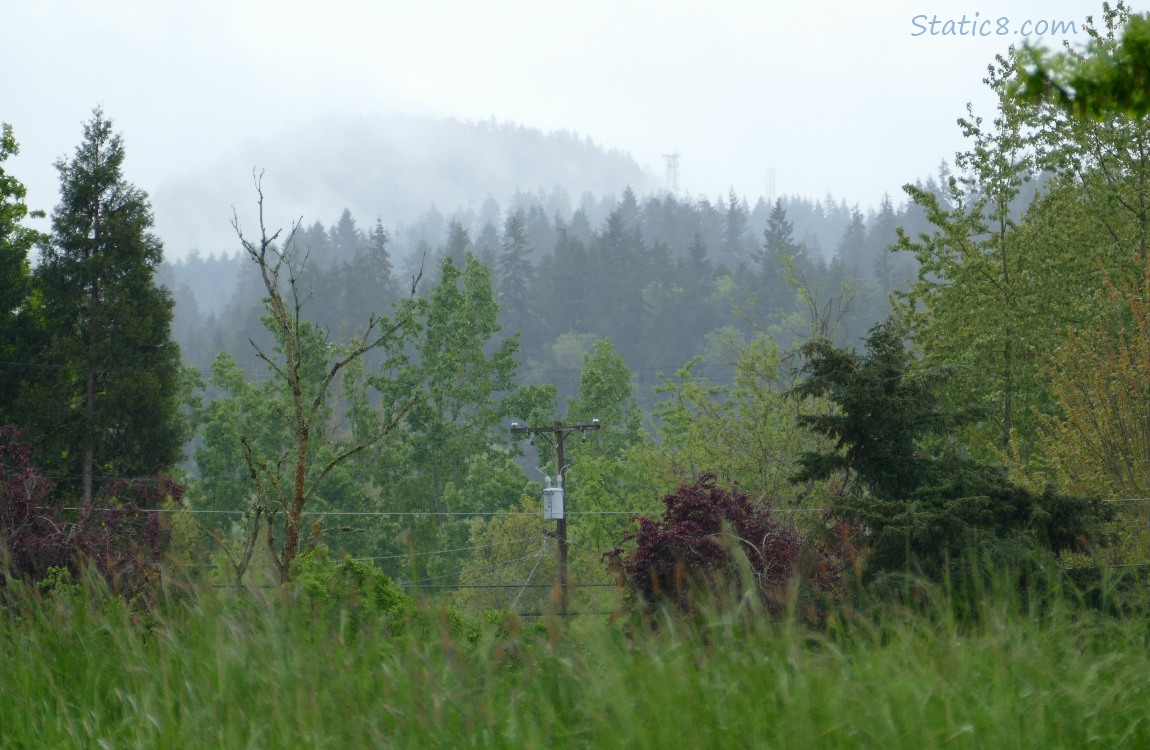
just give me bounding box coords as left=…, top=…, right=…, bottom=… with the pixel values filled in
left=30, top=109, right=185, bottom=503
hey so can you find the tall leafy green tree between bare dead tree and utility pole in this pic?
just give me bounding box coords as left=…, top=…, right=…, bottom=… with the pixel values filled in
left=373, top=253, right=554, bottom=580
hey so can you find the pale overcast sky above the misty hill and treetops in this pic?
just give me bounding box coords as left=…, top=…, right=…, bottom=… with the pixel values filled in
left=0, top=0, right=1131, bottom=254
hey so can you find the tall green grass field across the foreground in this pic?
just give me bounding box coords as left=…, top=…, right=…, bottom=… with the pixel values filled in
left=0, top=570, right=1150, bottom=750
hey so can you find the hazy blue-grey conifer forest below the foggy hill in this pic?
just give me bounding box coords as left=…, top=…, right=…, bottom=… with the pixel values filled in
left=160, top=179, right=946, bottom=403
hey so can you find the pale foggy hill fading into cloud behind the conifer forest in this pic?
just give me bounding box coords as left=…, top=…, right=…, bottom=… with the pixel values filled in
left=152, top=115, right=656, bottom=258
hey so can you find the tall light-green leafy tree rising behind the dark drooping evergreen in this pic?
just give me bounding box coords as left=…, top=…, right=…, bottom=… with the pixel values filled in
left=897, top=58, right=1048, bottom=451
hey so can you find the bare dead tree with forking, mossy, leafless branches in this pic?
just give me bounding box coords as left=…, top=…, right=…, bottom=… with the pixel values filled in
left=231, top=173, right=422, bottom=584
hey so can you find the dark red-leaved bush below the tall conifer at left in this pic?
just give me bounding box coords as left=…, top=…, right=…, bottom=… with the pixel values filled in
left=0, top=424, right=184, bottom=596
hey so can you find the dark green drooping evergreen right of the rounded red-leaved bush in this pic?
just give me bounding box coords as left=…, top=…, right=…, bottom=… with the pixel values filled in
left=794, top=321, right=1103, bottom=575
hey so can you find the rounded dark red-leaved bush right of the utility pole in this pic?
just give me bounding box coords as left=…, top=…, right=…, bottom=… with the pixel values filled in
left=604, top=474, right=845, bottom=614
